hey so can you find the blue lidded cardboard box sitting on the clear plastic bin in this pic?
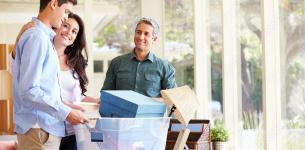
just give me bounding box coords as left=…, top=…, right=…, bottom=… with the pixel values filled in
left=99, top=90, right=166, bottom=118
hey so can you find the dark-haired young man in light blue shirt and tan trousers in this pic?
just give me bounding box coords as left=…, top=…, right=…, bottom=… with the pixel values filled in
left=13, top=0, right=88, bottom=150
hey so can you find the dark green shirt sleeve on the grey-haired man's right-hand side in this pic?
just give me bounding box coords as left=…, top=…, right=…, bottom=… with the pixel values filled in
left=161, top=62, right=177, bottom=89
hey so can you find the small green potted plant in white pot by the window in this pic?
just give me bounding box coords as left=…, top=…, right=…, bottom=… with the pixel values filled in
left=211, top=124, right=229, bottom=150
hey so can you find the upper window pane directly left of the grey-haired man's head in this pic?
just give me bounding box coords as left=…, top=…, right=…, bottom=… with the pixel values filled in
left=94, top=0, right=141, bottom=53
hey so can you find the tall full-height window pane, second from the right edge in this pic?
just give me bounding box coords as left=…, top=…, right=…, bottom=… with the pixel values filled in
left=238, top=0, right=263, bottom=150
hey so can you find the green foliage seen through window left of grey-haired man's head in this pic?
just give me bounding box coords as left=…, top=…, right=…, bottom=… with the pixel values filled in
left=94, top=0, right=141, bottom=53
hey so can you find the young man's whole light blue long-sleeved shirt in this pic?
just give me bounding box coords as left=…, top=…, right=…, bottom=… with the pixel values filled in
left=13, top=18, right=71, bottom=136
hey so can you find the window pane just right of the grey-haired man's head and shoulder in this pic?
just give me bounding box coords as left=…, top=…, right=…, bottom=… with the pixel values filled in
left=164, top=0, right=194, bottom=87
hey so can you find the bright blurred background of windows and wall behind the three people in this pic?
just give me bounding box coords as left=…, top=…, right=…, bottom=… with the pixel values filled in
left=0, top=0, right=305, bottom=150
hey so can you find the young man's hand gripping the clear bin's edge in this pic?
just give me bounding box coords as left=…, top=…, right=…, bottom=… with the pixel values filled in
left=66, top=109, right=89, bottom=125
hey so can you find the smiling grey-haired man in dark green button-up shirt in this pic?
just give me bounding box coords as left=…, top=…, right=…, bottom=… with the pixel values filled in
left=102, top=18, right=176, bottom=97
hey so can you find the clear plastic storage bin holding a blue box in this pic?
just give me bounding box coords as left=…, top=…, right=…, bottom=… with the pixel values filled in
left=74, top=118, right=170, bottom=150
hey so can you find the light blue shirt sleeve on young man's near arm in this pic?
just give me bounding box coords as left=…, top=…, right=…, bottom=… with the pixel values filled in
left=17, top=34, right=71, bottom=120
